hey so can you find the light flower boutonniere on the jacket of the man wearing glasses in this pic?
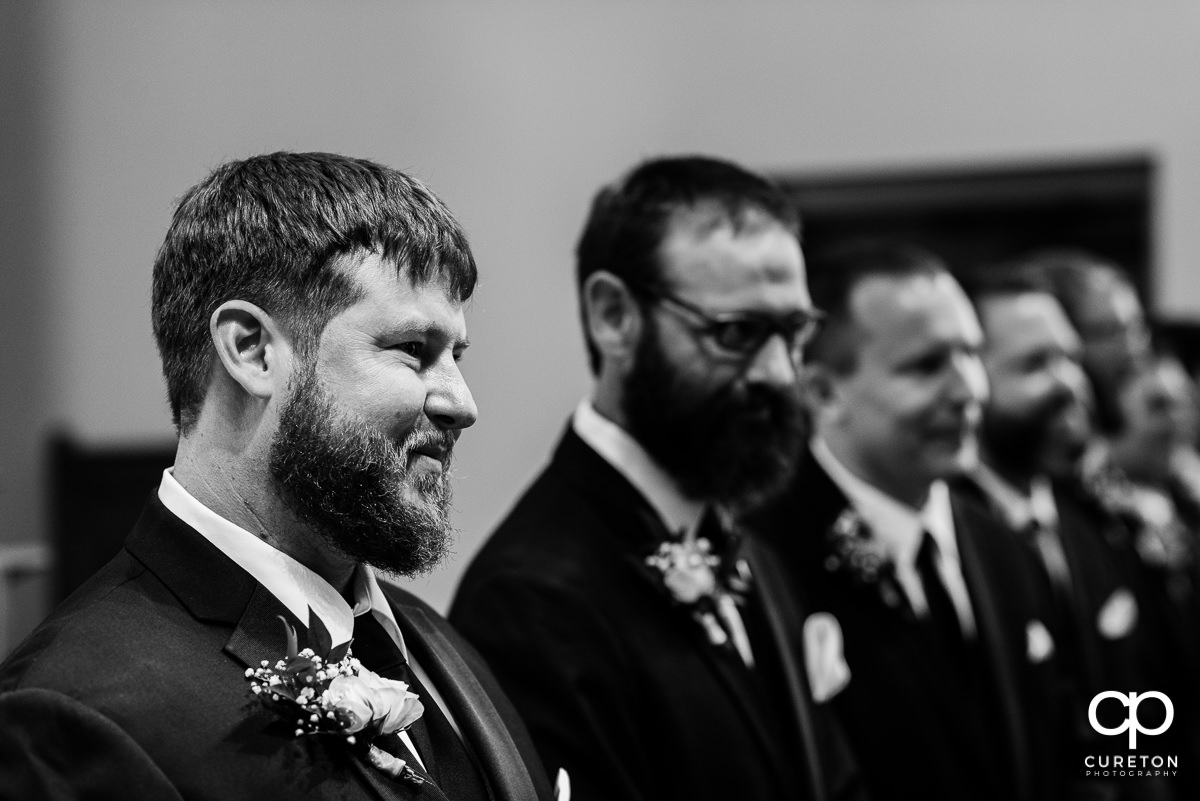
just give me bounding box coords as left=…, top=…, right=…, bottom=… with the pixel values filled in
left=644, top=531, right=750, bottom=648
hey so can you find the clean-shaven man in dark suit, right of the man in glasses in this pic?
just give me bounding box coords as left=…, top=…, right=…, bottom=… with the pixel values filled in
left=751, top=242, right=1061, bottom=801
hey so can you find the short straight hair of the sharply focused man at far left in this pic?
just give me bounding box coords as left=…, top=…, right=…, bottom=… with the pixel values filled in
left=151, top=152, right=478, bottom=434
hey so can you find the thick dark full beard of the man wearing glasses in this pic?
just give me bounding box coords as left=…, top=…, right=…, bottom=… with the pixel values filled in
left=624, top=327, right=808, bottom=511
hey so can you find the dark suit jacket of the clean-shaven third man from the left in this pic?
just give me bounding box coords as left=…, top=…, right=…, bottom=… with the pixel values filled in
left=750, top=454, right=1062, bottom=801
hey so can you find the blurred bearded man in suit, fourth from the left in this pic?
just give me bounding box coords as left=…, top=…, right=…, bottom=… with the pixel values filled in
left=966, top=264, right=1190, bottom=799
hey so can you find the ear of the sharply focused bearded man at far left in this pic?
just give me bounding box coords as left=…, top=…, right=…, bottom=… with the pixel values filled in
left=209, top=300, right=292, bottom=401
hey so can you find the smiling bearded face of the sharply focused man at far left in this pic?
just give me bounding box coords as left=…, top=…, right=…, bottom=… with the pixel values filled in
left=270, top=257, right=476, bottom=574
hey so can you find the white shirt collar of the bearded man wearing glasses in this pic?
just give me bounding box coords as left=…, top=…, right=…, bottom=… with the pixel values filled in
left=571, top=399, right=704, bottom=532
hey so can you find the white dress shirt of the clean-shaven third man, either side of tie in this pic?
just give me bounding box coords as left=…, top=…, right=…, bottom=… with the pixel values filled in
left=812, top=439, right=976, bottom=636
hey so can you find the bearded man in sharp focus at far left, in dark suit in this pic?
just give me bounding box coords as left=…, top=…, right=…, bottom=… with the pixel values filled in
left=0, top=153, right=553, bottom=801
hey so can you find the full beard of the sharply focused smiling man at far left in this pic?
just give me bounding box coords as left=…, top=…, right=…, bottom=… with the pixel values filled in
left=269, top=368, right=455, bottom=577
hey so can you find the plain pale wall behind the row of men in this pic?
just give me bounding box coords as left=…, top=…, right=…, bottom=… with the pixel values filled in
left=0, top=0, right=1200, bottom=645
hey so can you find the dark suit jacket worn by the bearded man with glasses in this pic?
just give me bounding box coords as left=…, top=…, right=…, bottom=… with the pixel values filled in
left=450, top=430, right=857, bottom=801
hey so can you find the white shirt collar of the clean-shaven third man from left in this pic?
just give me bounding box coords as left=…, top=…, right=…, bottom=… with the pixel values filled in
left=812, top=439, right=959, bottom=565
